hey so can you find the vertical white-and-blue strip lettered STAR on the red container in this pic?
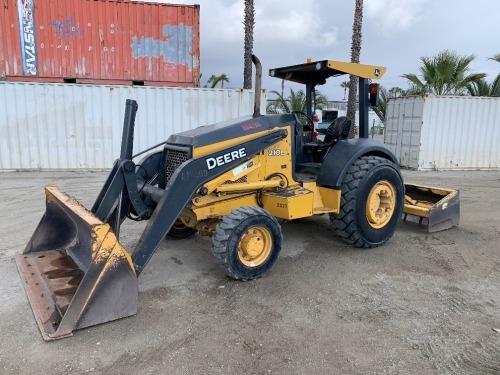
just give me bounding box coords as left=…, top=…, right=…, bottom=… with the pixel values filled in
left=17, top=0, right=38, bottom=76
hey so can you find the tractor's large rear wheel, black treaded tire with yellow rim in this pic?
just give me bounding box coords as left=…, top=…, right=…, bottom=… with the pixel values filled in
left=330, top=156, right=404, bottom=248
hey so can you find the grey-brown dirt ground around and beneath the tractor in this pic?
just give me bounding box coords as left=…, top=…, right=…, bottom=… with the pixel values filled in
left=0, top=171, right=500, bottom=375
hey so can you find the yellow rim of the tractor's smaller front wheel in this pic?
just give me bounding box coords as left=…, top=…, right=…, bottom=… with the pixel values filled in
left=238, top=227, right=272, bottom=267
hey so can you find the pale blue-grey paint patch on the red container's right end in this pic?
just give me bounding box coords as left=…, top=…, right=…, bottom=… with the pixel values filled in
left=130, top=23, right=193, bottom=70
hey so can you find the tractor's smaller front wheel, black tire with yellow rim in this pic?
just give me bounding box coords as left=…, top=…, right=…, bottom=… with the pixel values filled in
left=212, top=206, right=283, bottom=280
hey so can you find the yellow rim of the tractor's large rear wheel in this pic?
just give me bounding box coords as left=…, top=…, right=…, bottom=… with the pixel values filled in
left=366, top=181, right=396, bottom=229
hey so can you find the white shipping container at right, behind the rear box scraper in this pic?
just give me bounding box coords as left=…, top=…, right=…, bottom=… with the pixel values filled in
left=384, top=96, right=500, bottom=170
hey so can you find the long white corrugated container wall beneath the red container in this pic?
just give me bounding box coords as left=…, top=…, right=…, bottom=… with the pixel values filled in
left=0, top=82, right=266, bottom=169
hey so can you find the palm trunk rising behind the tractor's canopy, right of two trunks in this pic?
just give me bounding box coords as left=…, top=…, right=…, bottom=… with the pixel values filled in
left=347, top=0, right=363, bottom=138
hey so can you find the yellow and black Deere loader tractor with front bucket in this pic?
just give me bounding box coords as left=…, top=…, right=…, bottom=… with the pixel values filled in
left=16, top=56, right=458, bottom=340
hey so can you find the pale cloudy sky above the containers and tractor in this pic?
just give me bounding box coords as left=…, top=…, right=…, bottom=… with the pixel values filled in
left=141, top=0, right=500, bottom=100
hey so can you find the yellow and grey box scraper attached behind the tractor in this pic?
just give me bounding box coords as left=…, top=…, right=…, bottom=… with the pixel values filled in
left=403, top=184, right=460, bottom=232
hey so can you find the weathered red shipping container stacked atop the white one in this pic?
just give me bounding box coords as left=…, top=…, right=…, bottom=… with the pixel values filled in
left=0, top=0, right=200, bottom=87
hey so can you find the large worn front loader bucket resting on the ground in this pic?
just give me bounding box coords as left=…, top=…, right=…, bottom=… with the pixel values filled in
left=16, top=186, right=138, bottom=340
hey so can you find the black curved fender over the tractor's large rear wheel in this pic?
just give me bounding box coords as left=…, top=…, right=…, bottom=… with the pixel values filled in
left=317, top=138, right=401, bottom=187
